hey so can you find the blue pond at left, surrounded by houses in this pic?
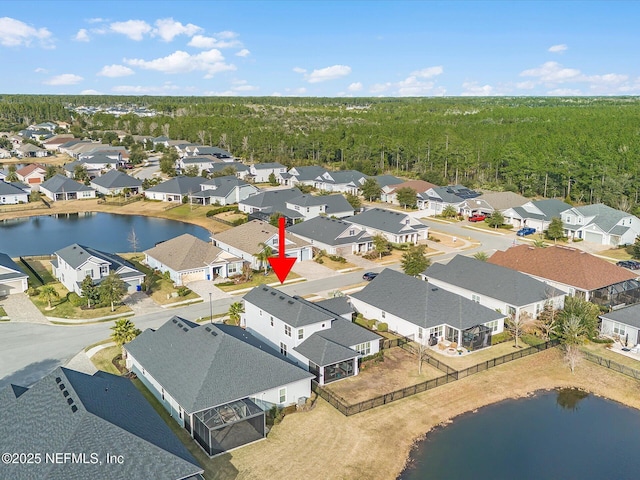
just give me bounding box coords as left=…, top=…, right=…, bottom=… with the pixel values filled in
left=0, top=212, right=211, bottom=257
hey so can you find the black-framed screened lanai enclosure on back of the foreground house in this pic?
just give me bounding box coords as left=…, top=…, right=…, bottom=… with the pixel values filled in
left=193, top=398, right=265, bottom=456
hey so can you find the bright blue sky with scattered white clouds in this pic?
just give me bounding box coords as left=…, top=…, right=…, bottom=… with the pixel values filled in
left=0, top=0, right=640, bottom=97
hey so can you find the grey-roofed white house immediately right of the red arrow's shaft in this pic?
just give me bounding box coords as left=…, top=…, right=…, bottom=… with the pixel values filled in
left=287, top=217, right=373, bottom=255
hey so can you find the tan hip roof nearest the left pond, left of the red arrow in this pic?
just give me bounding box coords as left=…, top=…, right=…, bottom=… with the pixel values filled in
left=144, top=233, right=228, bottom=272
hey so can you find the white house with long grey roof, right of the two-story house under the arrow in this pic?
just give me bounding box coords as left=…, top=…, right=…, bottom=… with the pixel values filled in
left=349, top=268, right=505, bottom=350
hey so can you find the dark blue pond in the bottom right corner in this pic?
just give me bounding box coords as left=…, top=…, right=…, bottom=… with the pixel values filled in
left=400, top=389, right=640, bottom=480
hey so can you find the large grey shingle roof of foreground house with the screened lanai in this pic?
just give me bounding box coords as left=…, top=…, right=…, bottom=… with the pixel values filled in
left=125, top=316, right=313, bottom=413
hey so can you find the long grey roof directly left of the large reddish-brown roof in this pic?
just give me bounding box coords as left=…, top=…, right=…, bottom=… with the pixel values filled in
left=423, top=255, right=566, bottom=307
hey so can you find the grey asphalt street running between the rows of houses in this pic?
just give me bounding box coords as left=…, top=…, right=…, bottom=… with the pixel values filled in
left=0, top=220, right=513, bottom=389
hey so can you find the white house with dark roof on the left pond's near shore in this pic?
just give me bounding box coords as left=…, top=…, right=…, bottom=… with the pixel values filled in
left=51, top=243, right=144, bottom=295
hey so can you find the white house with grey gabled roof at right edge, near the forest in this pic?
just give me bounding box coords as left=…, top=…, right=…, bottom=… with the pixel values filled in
left=559, top=203, right=640, bottom=247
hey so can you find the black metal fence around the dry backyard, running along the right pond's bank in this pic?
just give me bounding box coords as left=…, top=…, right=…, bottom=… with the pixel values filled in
left=312, top=338, right=560, bottom=416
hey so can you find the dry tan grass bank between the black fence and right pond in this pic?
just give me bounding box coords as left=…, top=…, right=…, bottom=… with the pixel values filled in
left=214, top=349, right=640, bottom=480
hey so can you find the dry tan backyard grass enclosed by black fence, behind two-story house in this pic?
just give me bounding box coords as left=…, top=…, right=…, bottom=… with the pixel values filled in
left=325, top=347, right=444, bottom=405
